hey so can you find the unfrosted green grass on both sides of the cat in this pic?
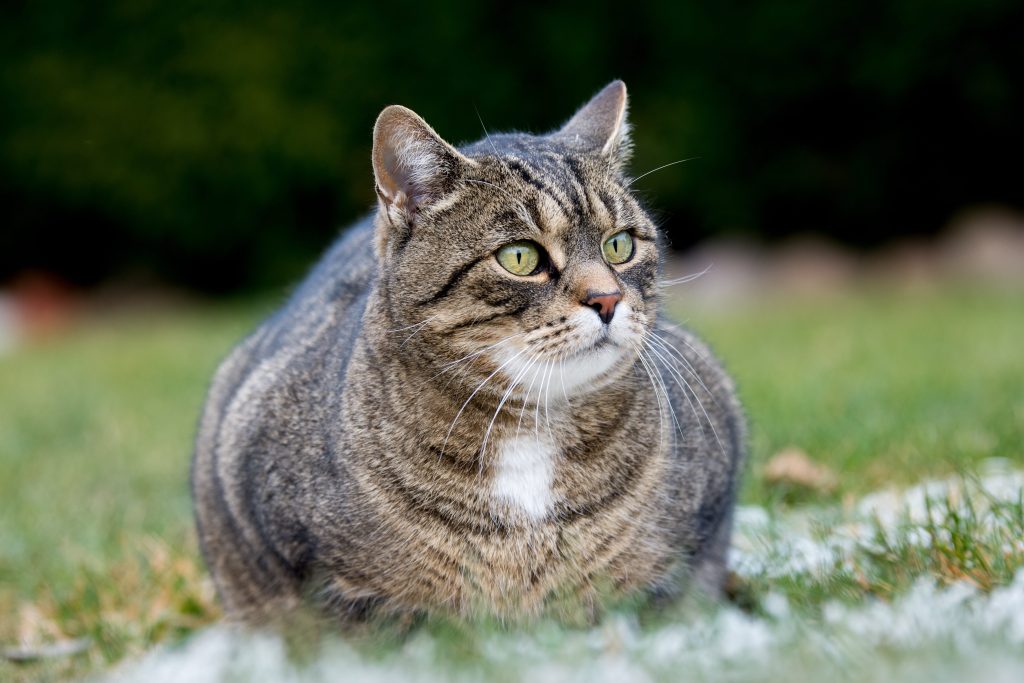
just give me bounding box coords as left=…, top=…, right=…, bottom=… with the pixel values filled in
left=0, top=287, right=1024, bottom=680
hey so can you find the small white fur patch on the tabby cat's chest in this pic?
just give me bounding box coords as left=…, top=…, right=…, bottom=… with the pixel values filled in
left=492, top=435, right=557, bottom=520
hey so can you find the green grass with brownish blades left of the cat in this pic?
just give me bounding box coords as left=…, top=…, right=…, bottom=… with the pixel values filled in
left=0, top=304, right=265, bottom=680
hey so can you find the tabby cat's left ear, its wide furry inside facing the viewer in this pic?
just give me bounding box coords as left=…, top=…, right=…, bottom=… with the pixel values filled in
left=373, top=104, right=474, bottom=222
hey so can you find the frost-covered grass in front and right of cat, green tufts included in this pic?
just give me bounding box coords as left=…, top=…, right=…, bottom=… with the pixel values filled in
left=101, top=463, right=1024, bottom=683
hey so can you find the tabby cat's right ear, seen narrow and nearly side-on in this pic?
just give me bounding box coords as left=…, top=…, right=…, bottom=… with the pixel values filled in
left=555, top=81, right=633, bottom=168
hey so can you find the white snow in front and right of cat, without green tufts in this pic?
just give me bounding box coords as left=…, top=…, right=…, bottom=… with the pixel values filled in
left=105, top=463, right=1024, bottom=683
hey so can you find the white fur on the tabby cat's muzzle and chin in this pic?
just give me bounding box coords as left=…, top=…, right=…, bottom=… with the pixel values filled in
left=492, top=303, right=642, bottom=402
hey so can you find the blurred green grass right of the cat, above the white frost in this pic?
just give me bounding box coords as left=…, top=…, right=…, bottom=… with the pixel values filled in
left=673, top=290, right=1024, bottom=502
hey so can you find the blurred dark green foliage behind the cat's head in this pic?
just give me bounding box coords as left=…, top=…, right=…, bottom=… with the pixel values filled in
left=0, top=0, right=1024, bottom=290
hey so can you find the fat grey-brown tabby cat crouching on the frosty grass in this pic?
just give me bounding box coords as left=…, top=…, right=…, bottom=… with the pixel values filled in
left=191, top=81, right=744, bottom=624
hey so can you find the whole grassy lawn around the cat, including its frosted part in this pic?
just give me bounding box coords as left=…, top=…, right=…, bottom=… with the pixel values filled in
left=0, top=286, right=1024, bottom=680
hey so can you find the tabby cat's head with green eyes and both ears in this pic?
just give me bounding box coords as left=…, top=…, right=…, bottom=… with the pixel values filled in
left=373, top=81, right=659, bottom=398
